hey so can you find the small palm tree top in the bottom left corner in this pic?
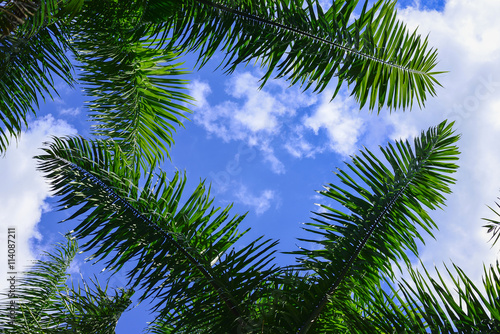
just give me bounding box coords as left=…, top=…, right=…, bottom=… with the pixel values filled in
left=0, top=238, right=133, bottom=334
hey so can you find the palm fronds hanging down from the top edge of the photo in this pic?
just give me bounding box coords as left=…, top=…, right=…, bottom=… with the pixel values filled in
left=0, top=0, right=439, bottom=160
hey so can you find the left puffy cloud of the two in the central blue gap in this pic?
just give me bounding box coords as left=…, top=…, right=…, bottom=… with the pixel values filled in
left=191, top=72, right=316, bottom=174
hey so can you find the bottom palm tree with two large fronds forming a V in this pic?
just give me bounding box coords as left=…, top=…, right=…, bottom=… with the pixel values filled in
left=33, top=122, right=500, bottom=333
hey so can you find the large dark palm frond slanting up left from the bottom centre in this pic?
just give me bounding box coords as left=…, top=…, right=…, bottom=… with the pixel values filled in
left=38, top=138, right=276, bottom=333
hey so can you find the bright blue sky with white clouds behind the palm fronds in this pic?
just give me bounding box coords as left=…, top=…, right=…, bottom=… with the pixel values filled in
left=0, top=0, right=500, bottom=334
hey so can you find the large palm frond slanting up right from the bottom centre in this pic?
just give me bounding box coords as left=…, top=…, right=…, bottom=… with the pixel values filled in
left=288, top=122, right=458, bottom=333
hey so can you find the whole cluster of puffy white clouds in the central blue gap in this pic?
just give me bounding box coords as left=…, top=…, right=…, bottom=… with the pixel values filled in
left=190, top=72, right=364, bottom=170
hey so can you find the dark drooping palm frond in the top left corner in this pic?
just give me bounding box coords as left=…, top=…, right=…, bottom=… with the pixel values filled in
left=0, top=1, right=76, bottom=152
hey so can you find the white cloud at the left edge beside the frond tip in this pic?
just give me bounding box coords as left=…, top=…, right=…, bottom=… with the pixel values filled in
left=0, top=115, right=76, bottom=290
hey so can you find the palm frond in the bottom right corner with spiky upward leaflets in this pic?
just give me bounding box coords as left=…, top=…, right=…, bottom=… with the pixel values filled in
left=365, top=262, right=500, bottom=334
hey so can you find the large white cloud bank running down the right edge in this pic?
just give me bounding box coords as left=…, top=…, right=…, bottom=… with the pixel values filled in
left=384, top=0, right=500, bottom=294
